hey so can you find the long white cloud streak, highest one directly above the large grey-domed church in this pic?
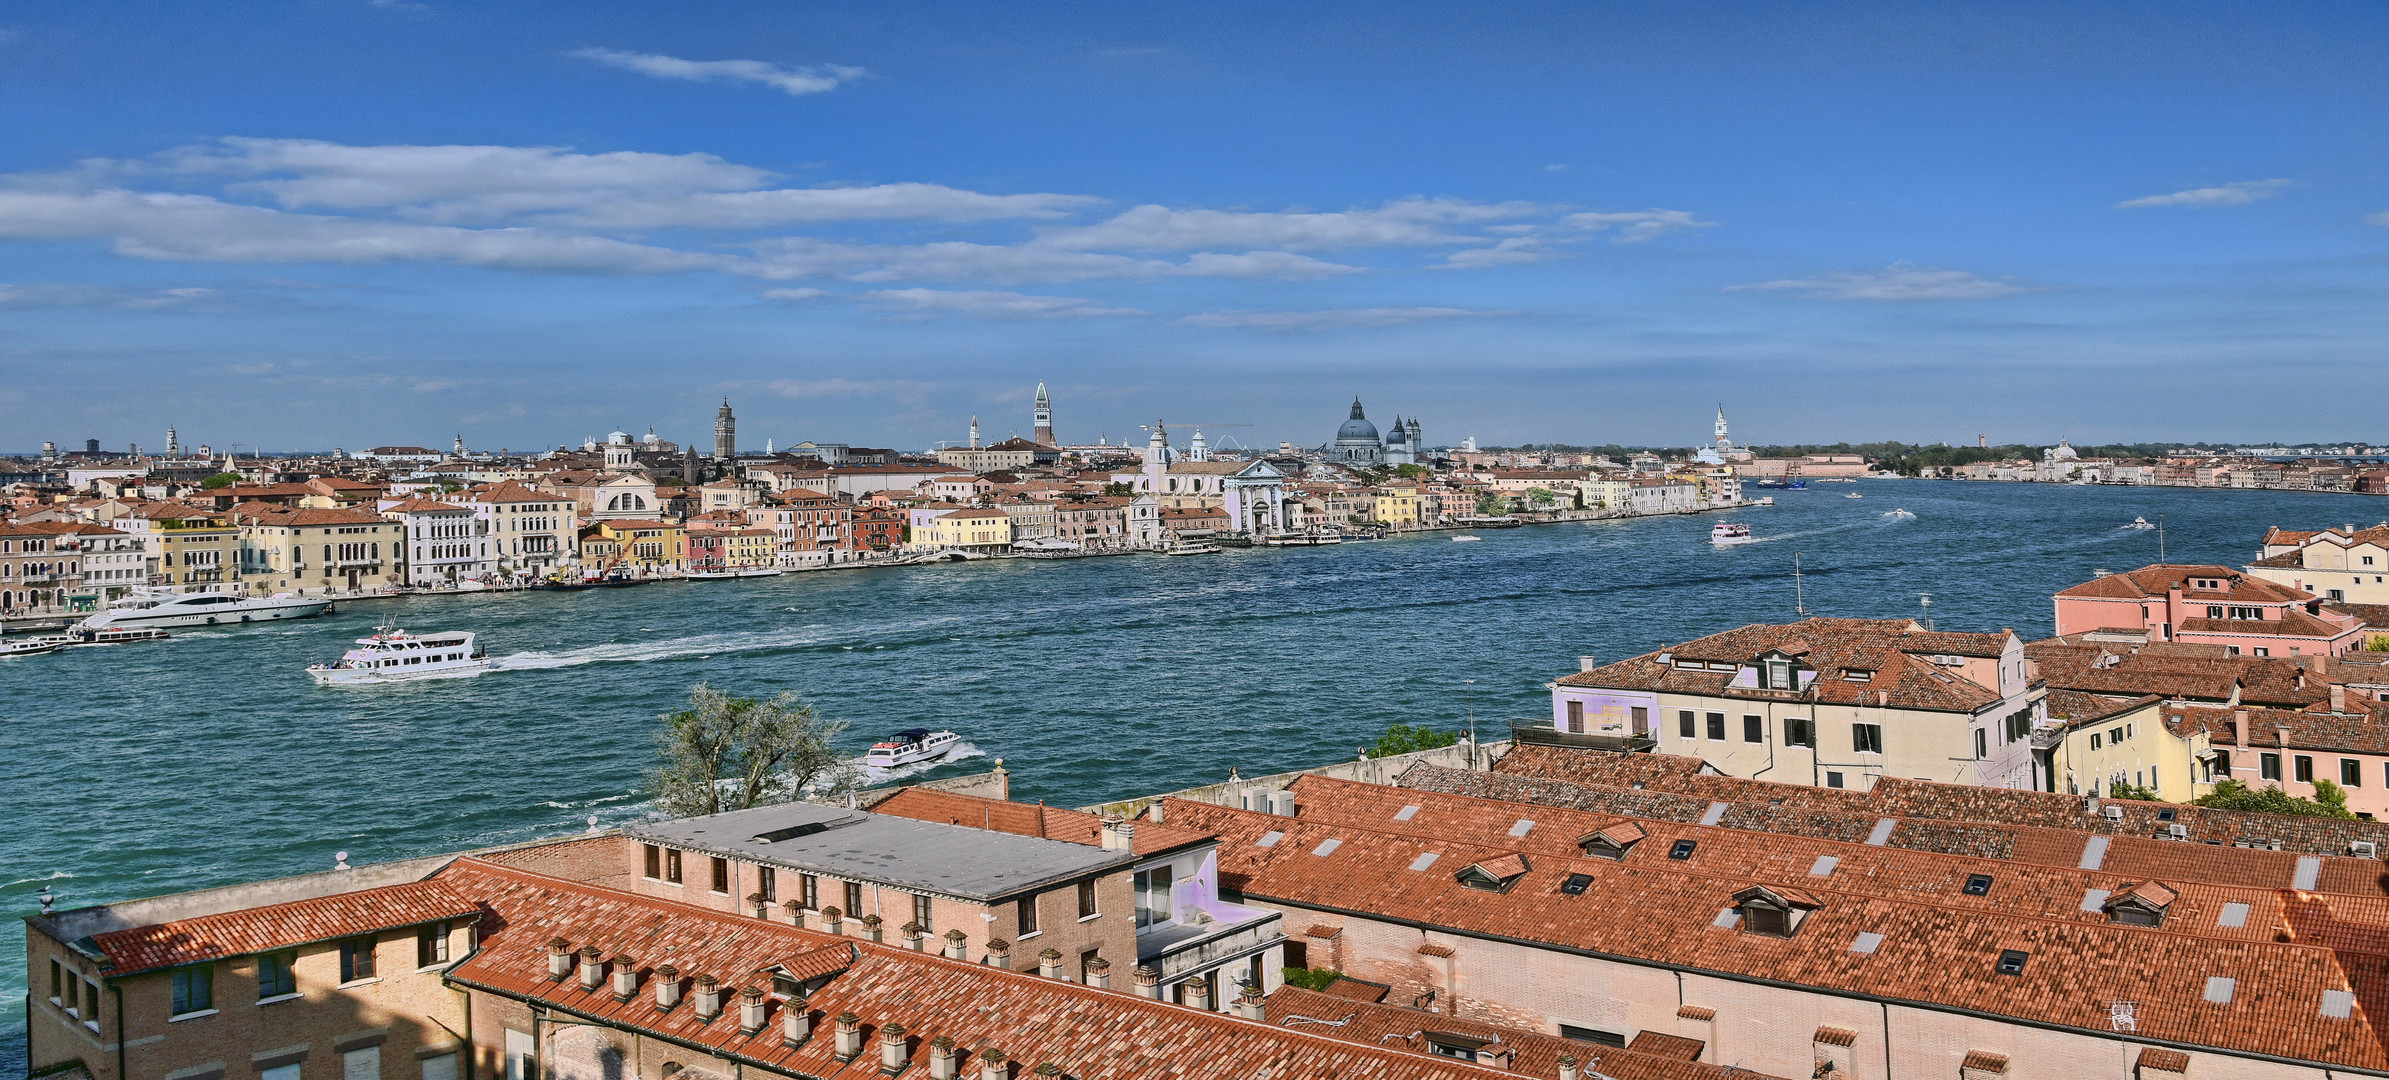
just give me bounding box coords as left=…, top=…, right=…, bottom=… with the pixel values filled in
left=1037, top=198, right=1541, bottom=251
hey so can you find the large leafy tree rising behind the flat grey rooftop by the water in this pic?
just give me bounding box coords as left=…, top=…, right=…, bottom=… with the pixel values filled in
left=647, top=683, right=860, bottom=817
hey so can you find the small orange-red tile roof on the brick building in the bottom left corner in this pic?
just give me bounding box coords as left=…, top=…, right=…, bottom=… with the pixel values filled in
left=91, top=882, right=480, bottom=975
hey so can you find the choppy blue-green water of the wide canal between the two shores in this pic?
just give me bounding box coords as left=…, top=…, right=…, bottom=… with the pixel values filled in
left=0, top=480, right=2389, bottom=1061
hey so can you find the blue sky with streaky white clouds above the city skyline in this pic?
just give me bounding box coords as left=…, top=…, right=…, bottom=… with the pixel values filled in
left=0, top=0, right=2389, bottom=449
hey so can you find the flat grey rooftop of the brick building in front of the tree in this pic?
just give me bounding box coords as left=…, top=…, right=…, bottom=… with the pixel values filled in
left=624, top=803, right=1137, bottom=901
